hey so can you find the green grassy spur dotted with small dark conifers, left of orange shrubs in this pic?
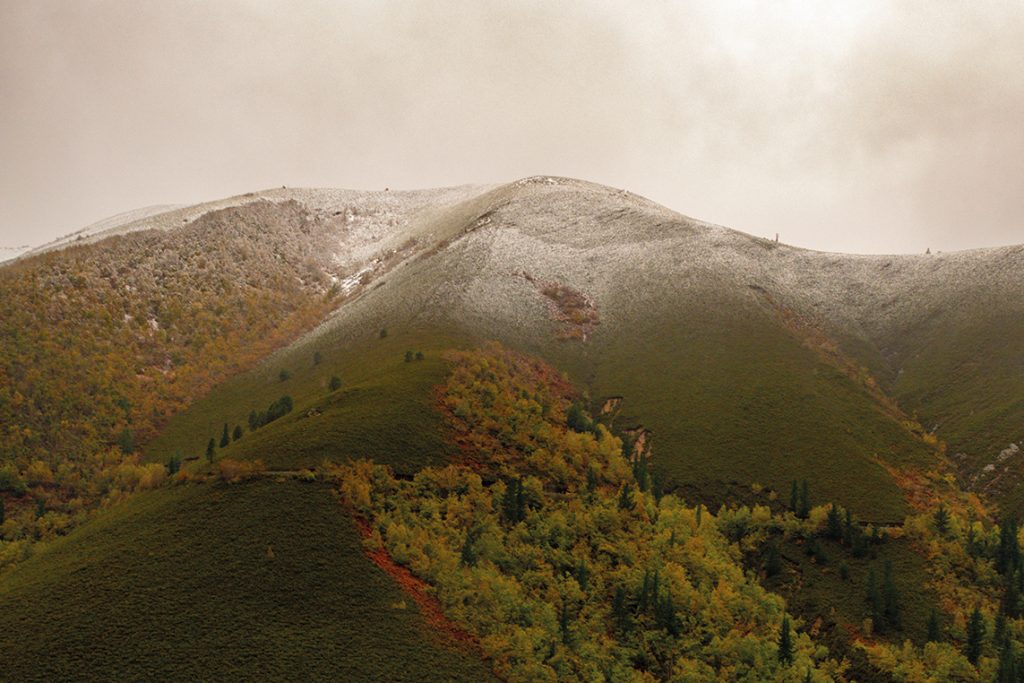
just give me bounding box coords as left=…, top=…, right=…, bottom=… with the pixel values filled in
left=146, top=329, right=464, bottom=472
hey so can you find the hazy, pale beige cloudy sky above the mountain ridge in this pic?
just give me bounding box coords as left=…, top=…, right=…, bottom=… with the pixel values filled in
left=0, top=0, right=1024, bottom=252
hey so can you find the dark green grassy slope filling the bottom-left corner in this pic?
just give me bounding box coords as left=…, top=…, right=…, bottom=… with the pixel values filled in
left=0, top=480, right=488, bottom=681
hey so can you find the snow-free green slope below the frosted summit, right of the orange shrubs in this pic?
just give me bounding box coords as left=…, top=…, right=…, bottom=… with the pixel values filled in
left=581, top=290, right=931, bottom=520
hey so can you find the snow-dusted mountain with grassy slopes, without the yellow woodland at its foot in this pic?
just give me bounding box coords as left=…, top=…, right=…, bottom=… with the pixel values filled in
left=0, top=176, right=1024, bottom=680
